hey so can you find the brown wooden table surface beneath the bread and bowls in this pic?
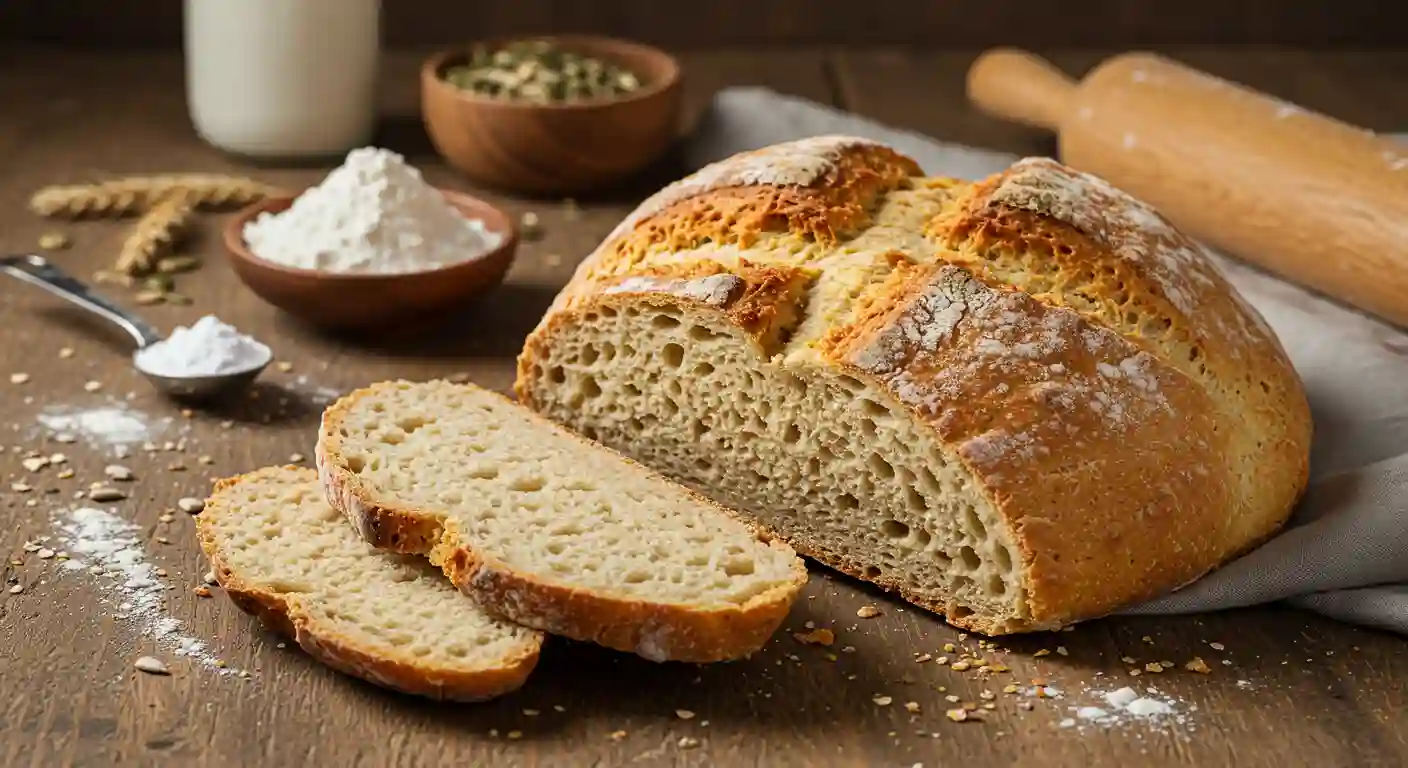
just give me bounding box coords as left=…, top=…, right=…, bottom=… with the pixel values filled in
left=0, top=49, right=1408, bottom=767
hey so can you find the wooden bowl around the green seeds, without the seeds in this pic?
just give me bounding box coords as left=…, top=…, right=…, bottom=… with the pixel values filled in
left=421, top=35, right=680, bottom=194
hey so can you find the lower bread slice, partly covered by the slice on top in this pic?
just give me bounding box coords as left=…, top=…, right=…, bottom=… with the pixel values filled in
left=196, top=466, right=542, bottom=702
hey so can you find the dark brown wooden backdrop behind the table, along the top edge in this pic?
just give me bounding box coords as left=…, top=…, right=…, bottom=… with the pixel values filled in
left=0, top=0, right=1405, bottom=49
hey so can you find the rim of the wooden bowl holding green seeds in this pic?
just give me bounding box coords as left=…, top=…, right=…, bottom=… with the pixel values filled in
left=421, top=35, right=680, bottom=111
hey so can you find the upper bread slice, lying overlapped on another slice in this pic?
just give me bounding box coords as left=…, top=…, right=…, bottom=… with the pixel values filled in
left=317, top=382, right=807, bottom=662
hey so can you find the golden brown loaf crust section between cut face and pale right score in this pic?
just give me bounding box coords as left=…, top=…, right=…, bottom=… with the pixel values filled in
left=828, top=266, right=1233, bottom=628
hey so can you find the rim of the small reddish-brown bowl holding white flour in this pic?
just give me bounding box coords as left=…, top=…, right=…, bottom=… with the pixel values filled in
left=224, top=187, right=518, bottom=283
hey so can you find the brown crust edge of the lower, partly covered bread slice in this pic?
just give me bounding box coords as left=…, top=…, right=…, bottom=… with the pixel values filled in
left=196, top=466, right=542, bottom=702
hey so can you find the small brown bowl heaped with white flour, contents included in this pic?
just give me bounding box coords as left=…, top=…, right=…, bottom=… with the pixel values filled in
left=224, top=149, right=518, bottom=331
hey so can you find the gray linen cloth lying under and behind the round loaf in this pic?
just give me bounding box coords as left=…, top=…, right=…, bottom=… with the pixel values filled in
left=684, top=87, right=1408, bottom=634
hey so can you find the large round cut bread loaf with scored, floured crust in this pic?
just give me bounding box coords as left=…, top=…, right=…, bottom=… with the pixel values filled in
left=515, top=137, right=1311, bottom=634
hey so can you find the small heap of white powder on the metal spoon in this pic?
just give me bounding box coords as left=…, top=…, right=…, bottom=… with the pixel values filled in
left=135, top=314, right=273, bottom=378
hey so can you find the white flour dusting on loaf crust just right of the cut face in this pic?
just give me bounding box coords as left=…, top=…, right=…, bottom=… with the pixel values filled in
left=849, top=266, right=1170, bottom=464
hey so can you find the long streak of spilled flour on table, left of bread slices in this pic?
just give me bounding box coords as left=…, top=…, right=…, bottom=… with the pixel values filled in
left=48, top=507, right=241, bottom=675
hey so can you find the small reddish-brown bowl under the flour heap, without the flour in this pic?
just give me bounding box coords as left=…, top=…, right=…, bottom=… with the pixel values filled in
left=224, top=189, right=518, bottom=335
